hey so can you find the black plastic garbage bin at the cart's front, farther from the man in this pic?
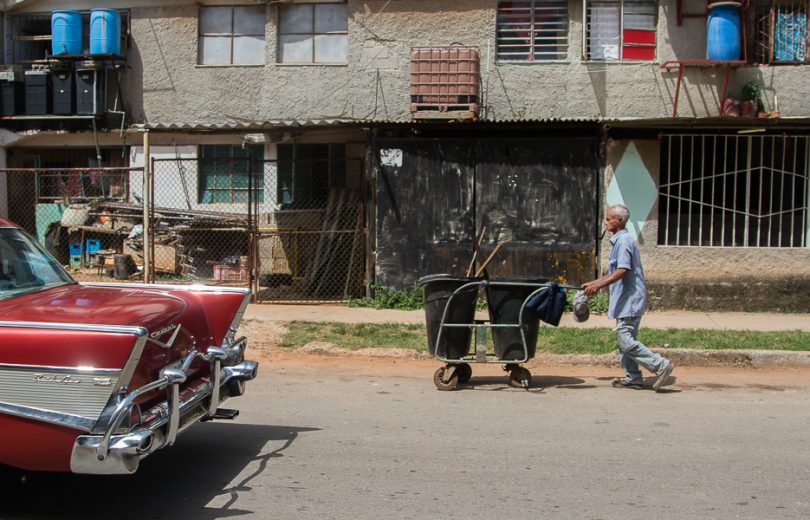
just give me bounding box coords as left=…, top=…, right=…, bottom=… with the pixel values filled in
left=418, top=274, right=479, bottom=359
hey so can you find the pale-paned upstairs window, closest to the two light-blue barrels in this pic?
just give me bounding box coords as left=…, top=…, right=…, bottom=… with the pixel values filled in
left=199, top=5, right=264, bottom=65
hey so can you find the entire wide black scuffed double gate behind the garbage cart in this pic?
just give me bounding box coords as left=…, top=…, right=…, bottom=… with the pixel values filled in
left=375, top=138, right=598, bottom=287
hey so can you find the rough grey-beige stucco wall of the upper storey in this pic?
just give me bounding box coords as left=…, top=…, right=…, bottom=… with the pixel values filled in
left=110, top=0, right=810, bottom=122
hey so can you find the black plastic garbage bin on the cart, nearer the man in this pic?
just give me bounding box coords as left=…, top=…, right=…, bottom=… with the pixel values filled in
left=487, top=278, right=548, bottom=360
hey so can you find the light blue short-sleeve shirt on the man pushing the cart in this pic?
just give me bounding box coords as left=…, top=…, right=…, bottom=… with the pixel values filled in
left=608, top=229, right=647, bottom=319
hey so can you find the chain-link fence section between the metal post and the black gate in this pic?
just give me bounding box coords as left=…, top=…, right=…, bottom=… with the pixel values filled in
left=152, top=153, right=365, bottom=302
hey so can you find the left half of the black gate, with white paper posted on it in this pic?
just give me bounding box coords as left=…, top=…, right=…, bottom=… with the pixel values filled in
left=376, top=139, right=475, bottom=287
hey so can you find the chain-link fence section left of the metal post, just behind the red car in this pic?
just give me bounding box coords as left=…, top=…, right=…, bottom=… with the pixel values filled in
left=0, top=168, right=143, bottom=281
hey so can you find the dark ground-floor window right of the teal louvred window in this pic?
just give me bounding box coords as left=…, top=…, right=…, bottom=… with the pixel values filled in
left=278, top=144, right=346, bottom=207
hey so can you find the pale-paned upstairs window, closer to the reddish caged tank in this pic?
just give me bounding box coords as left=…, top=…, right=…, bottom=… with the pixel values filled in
left=278, top=4, right=349, bottom=63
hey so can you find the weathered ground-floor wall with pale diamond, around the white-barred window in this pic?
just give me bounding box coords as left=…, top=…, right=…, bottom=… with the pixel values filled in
left=600, top=140, right=810, bottom=311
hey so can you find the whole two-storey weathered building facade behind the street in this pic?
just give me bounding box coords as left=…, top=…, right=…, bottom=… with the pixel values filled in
left=0, top=0, right=810, bottom=310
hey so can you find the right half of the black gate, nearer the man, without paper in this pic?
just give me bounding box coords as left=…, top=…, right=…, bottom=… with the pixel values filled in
left=475, top=138, right=599, bottom=283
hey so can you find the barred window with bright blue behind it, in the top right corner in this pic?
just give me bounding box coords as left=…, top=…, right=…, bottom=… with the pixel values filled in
left=750, top=0, right=808, bottom=64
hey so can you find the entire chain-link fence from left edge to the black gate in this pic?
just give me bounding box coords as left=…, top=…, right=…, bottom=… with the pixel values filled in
left=0, top=153, right=365, bottom=302
